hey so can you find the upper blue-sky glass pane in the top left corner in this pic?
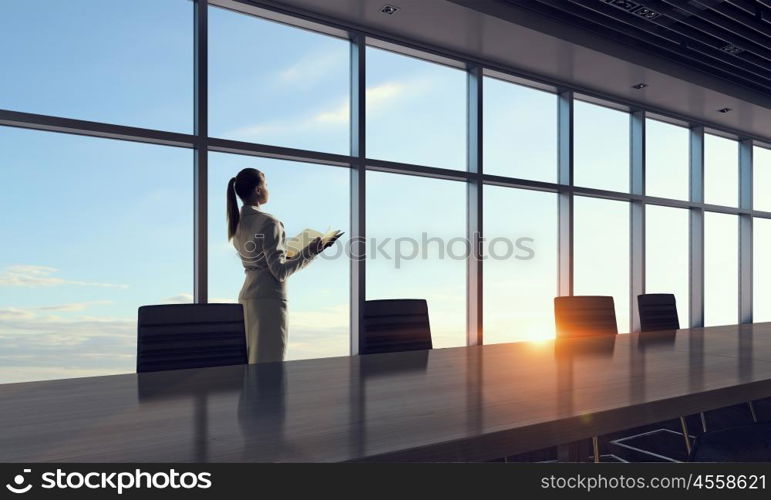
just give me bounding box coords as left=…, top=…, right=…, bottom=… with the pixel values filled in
left=0, top=0, right=193, bottom=133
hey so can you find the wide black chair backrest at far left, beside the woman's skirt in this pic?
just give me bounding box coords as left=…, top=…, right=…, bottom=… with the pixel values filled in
left=137, top=304, right=247, bottom=372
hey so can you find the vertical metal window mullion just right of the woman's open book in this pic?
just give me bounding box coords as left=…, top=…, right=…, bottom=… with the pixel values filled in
left=350, top=33, right=367, bottom=355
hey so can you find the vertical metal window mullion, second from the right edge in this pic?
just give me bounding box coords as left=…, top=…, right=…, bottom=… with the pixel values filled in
left=689, top=126, right=704, bottom=328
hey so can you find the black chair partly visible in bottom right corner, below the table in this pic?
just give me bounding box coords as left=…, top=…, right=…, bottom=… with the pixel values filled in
left=689, top=423, right=771, bottom=462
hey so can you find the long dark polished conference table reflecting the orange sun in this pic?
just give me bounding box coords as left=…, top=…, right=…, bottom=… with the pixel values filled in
left=0, top=323, right=771, bottom=463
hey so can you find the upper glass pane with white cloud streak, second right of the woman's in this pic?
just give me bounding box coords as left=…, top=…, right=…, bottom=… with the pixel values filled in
left=367, top=47, right=466, bottom=170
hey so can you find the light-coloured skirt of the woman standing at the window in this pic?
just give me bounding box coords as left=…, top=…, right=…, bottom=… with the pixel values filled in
left=239, top=299, right=288, bottom=363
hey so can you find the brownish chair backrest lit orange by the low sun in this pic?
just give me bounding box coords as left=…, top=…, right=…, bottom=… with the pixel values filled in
left=554, top=295, right=618, bottom=338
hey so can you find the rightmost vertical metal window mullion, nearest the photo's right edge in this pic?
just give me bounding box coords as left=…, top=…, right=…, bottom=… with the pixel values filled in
left=739, top=139, right=753, bottom=323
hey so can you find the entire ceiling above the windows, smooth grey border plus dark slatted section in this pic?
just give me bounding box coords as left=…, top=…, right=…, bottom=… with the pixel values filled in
left=240, top=0, right=771, bottom=141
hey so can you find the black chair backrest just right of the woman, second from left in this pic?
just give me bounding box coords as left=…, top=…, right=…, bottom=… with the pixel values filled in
left=359, top=299, right=433, bottom=354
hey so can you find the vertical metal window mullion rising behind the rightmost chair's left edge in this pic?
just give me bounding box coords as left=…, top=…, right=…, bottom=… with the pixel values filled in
left=629, top=110, right=645, bottom=332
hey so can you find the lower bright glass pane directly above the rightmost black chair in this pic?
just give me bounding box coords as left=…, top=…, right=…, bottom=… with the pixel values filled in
left=645, top=205, right=691, bottom=328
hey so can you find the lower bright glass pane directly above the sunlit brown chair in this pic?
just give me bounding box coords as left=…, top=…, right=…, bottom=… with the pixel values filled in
left=573, top=196, right=629, bottom=332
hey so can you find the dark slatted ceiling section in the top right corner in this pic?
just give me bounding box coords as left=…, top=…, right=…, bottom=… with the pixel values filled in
left=494, top=0, right=771, bottom=95
